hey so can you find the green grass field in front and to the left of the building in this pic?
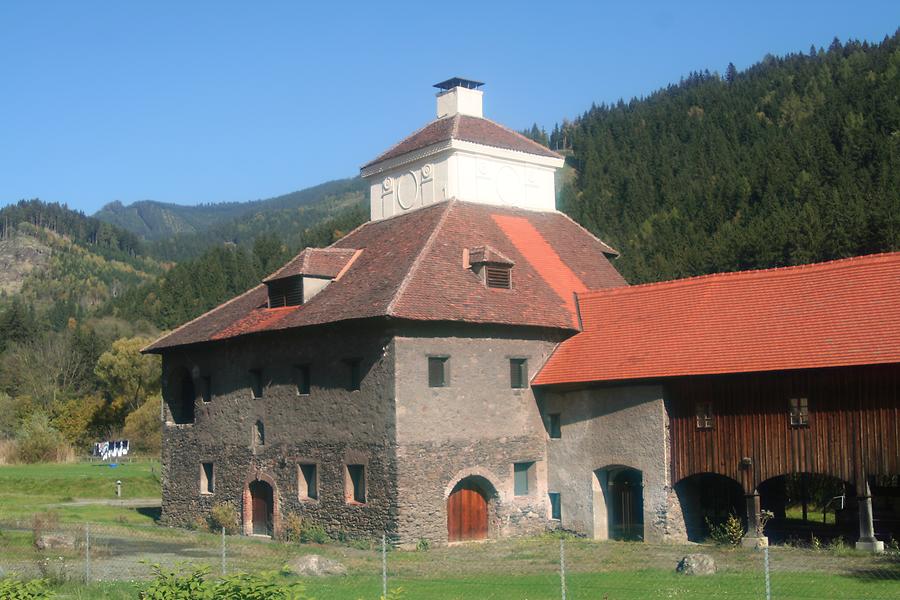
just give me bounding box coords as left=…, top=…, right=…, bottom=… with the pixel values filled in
left=0, top=462, right=900, bottom=600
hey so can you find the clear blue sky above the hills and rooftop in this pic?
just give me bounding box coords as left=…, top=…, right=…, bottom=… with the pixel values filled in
left=0, top=0, right=900, bottom=213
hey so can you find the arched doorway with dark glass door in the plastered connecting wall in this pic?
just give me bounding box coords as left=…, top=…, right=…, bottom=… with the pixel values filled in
left=593, top=466, right=644, bottom=541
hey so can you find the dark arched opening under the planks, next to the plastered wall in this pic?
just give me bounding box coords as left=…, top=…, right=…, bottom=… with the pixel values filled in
left=675, top=473, right=746, bottom=542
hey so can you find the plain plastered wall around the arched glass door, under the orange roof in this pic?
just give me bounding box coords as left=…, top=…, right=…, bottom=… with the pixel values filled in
left=538, top=385, right=687, bottom=542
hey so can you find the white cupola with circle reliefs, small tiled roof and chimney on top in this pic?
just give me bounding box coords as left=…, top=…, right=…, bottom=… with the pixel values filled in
left=360, top=77, right=564, bottom=221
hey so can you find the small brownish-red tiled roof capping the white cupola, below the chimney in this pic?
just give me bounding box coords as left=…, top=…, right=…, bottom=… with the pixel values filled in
left=363, top=115, right=562, bottom=169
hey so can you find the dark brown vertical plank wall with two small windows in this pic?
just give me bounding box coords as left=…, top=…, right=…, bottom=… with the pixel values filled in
left=666, top=364, right=900, bottom=492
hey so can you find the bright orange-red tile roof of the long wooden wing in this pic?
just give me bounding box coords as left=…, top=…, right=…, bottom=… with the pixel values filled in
left=534, top=253, right=900, bottom=385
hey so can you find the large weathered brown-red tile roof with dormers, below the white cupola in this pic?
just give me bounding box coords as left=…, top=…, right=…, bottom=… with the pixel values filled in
left=146, top=200, right=626, bottom=352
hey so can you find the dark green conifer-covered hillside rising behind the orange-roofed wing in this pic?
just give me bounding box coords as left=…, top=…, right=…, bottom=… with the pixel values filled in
left=560, top=32, right=900, bottom=283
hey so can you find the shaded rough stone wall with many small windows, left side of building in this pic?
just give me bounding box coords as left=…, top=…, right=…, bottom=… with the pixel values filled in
left=163, top=324, right=397, bottom=537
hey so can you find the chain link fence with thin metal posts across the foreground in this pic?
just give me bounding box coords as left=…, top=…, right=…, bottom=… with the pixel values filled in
left=0, top=516, right=900, bottom=600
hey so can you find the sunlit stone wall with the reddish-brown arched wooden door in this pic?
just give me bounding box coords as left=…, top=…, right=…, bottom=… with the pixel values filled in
left=395, top=325, right=559, bottom=544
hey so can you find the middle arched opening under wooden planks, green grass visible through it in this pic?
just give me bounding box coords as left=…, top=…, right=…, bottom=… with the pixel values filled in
left=757, top=473, right=858, bottom=543
